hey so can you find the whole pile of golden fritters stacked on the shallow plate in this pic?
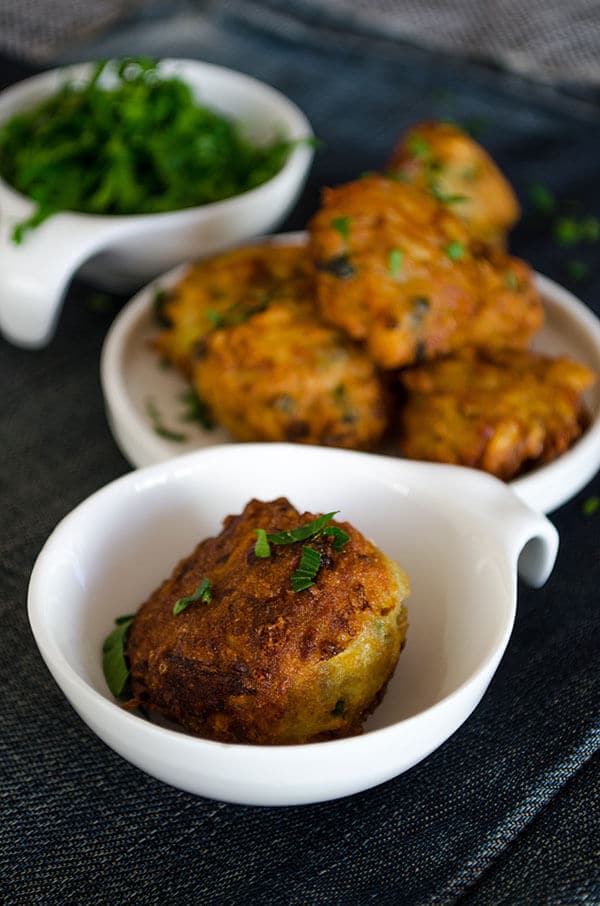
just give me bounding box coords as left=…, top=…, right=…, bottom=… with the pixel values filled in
left=157, top=123, right=594, bottom=488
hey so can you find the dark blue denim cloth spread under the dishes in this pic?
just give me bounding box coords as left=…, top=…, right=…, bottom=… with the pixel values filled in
left=0, top=5, right=600, bottom=906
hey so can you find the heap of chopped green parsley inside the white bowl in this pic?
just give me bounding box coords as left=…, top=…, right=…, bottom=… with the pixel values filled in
left=0, top=57, right=296, bottom=242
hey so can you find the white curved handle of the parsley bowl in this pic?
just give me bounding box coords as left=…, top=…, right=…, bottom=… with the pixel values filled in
left=0, top=207, right=129, bottom=349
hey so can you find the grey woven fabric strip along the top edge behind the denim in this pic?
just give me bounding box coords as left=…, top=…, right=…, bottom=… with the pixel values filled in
left=0, top=0, right=600, bottom=85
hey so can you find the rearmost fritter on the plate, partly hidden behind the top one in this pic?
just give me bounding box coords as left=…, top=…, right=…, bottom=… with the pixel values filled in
left=388, top=123, right=520, bottom=248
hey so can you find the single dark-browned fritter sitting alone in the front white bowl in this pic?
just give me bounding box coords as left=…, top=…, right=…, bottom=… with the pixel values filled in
left=126, top=498, right=408, bottom=745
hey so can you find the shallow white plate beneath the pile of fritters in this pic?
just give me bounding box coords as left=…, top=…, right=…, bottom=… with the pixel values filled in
left=101, top=233, right=600, bottom=513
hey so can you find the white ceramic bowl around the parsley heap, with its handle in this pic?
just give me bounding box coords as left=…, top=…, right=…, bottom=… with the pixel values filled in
left=0, top=60, right=313, bottom=347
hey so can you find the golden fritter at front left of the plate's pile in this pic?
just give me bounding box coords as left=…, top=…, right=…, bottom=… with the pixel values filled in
left=193, top=300, right=388, bottom=449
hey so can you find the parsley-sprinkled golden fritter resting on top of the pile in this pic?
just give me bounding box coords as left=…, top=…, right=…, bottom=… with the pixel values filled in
left=310, top=176, right=542, bottom=369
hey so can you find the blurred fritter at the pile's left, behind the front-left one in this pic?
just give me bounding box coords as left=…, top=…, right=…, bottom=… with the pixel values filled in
left=155, top=244, right=314, bottom=377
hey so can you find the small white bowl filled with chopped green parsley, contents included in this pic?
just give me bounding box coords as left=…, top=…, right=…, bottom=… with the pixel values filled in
left=0, top=58, right=313, bottom=347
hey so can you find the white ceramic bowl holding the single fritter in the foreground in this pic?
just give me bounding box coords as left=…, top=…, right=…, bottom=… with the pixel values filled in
left=29, top=444, right=558, bottom=805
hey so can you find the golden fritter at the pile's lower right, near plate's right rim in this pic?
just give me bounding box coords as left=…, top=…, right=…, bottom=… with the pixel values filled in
left=399, top=349, right=595, bottom=480
